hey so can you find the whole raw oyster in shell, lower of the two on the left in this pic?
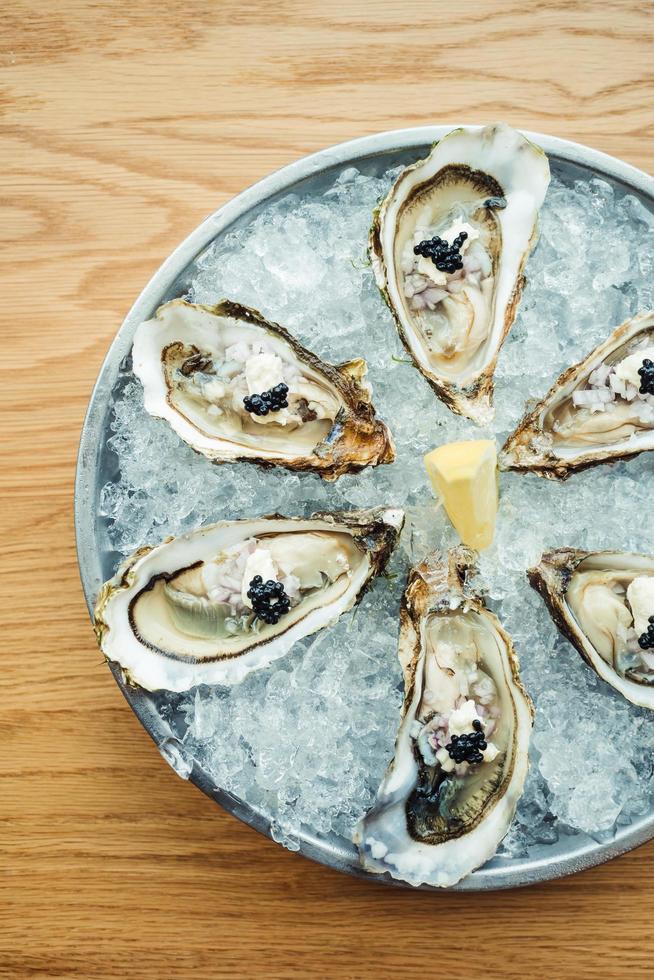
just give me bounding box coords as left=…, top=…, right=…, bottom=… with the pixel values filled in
left=95, top=508, right=404, bottom=691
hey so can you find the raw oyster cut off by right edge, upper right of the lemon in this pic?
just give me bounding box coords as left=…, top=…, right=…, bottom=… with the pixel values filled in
left=500, top=311, right=654, bottom=480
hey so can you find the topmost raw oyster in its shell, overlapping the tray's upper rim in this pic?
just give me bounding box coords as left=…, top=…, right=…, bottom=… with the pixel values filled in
left=370, top=124, right=550, bottom=425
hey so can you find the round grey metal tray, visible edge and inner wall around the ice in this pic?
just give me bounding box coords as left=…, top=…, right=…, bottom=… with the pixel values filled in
left=75, top=126, right=654, bottom=891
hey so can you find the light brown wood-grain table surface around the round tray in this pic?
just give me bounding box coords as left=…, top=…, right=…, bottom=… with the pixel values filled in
left=0, top=0, right=654, bottom=980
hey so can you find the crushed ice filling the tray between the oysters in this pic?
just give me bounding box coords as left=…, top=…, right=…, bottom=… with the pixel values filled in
left=101, top=168, right=654, bottom=857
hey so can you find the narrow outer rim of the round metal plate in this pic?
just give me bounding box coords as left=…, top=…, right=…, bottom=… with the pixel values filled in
left=74, top=125, right=654, bottom=891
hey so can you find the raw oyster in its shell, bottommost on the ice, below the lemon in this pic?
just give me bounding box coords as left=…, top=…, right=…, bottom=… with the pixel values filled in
left=355, top=546, right=533, bottom=887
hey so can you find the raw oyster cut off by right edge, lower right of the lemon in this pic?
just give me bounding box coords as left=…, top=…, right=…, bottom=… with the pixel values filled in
left=527, top=548, right=654, bottom=708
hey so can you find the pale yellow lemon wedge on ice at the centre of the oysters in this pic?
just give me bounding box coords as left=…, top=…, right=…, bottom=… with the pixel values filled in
left=425, top=439, right=498, bottom=551
